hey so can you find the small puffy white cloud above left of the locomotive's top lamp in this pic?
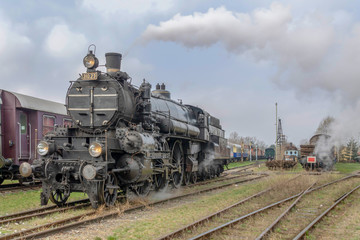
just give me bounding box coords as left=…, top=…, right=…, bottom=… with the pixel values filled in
left=45, top=24, right=87, bottom=57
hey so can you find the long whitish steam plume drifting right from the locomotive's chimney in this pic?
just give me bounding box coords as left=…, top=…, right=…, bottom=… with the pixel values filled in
left=141, top=3, right=360, bottom=102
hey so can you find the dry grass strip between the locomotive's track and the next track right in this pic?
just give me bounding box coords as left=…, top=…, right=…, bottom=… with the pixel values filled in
left=50, top=175, right=276, bottom=239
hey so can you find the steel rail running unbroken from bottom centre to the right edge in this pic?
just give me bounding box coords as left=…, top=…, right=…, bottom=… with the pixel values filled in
left=190, top=174, right=359, bottom=240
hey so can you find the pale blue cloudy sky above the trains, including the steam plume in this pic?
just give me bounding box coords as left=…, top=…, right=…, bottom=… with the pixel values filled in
left=0, top=0, right=360, bottom=144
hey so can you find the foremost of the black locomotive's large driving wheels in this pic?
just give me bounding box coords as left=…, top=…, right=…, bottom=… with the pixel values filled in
left=171, top=141, right=184, bottom=188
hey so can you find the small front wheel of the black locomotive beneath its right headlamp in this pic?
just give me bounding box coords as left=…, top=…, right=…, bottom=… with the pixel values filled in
left=99, top=173, right=118, bottom=207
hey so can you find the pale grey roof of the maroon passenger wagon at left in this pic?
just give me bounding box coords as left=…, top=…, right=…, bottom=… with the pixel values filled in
left=10, top=92, right=67, bottom=115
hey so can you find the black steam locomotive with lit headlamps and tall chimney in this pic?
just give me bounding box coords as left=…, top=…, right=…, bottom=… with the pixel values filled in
left=20, top=46, right=229, bottom=208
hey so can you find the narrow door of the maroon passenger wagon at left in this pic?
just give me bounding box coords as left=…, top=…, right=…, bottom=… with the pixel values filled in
left=17, top=111, right=30, bottom=161
